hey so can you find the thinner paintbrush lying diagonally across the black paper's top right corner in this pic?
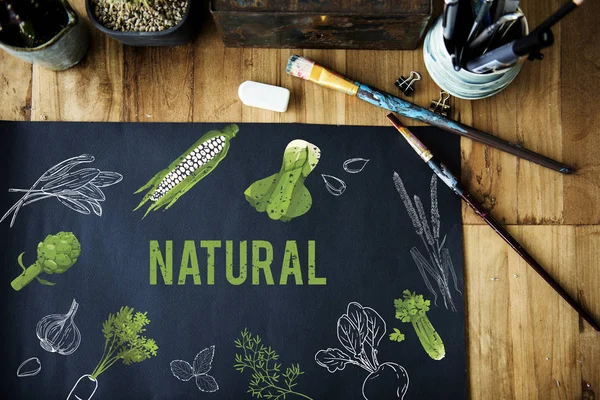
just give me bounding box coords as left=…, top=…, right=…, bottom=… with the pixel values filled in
left=387, top=114, right=600, bottom=331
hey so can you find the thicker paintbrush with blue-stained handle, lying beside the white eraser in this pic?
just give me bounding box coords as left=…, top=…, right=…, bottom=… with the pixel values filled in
left=286, top=55, right=573, bottom=174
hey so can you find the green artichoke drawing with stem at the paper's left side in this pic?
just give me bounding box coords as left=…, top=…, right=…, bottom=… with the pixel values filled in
left=10, top=232, right=81, bottom=290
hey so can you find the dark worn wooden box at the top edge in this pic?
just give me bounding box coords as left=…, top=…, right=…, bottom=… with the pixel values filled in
left=210, top=0, right=442, bottom=50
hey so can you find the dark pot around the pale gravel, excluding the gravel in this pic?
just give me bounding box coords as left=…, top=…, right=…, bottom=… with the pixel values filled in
left=85, top=0, right=195, bottom=47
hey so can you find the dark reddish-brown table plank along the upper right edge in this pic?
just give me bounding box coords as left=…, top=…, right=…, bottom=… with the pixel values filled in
left=560, top=1, right=600, bottom=223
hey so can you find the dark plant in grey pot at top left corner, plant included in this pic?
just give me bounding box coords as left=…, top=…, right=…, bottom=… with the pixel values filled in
left=0, top=0, right=89, bottom=71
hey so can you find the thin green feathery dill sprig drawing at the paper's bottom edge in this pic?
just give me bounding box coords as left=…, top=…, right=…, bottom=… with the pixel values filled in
left=234, top=329, right=312, bottom=400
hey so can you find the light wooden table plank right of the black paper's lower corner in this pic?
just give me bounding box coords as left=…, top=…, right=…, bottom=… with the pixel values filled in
left=463, top=225, right=600, bottom=399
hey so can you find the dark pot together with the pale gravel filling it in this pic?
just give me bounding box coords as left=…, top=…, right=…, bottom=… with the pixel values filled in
left=85, top=0, right=195, bottom=46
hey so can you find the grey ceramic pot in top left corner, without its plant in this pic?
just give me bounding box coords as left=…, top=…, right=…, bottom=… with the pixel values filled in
left=0, top=0, right=90, bottom=71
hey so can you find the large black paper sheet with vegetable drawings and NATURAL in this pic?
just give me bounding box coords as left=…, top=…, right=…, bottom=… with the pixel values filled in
left=0, top=122, right=466, bottom=400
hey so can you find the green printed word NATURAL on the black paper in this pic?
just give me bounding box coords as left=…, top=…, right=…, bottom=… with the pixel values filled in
left=150, top=240, right=327, bottom=285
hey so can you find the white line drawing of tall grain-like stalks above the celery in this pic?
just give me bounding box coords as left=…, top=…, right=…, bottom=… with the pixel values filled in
left=393, top=172, right=462, bottom=311
